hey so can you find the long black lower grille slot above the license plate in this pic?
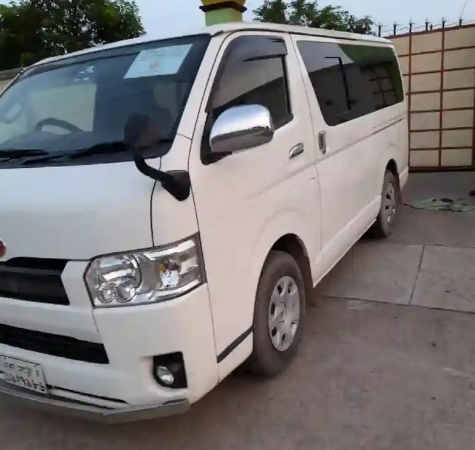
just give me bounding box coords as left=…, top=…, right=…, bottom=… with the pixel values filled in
left=0, top=324, right=109, bottom=364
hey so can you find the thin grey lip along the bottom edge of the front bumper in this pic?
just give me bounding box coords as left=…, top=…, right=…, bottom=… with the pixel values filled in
left=0, top=385, right=190, bottom=423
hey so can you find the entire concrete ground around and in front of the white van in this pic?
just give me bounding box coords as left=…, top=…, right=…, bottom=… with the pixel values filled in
left=0, top=173, right=475, bottom=450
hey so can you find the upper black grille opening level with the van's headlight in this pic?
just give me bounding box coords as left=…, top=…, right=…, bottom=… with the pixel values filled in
left=0, top=258, right=69, bottom=305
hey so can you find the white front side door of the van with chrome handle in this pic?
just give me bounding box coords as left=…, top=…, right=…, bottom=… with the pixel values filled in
left=190, top=32, right=320, bottom=378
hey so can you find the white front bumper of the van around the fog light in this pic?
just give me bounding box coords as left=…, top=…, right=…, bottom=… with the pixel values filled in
left=0, top=282, right=218, bottom=414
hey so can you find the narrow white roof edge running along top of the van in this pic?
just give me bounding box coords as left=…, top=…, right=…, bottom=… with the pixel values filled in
left=34, top=22, right=391, bottom=66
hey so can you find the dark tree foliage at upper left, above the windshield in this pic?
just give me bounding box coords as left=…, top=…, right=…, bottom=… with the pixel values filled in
left=0, top=0, right=144, bottom=69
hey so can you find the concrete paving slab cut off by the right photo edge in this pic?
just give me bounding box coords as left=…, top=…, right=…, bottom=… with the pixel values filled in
left=411, top=246, right=475, bottom=312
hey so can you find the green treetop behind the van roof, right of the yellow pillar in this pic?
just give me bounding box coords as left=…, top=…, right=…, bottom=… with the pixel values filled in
left=254, top=0, right=374, bottom=34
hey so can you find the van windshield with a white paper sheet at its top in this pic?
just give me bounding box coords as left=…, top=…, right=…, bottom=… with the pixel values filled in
left=0, top=36, right=210, bottom=168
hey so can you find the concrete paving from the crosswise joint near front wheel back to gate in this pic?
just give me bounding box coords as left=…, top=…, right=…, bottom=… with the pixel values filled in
left=317, top=173, right=475, bottom=312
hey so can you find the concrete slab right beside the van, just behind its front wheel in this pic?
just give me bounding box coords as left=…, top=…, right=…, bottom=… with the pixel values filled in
left=317, top=243, right=423, bottom=305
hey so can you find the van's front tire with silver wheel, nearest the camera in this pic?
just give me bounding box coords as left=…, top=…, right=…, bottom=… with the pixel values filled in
left=246, top=251, right=306, bottom=378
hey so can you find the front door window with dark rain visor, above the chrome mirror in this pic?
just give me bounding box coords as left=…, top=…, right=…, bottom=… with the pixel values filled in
left=208, top=36, right=292, bottom=129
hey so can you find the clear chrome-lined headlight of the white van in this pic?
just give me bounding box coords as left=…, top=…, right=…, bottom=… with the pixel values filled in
left=86, top=238, right=203, bottom=307
